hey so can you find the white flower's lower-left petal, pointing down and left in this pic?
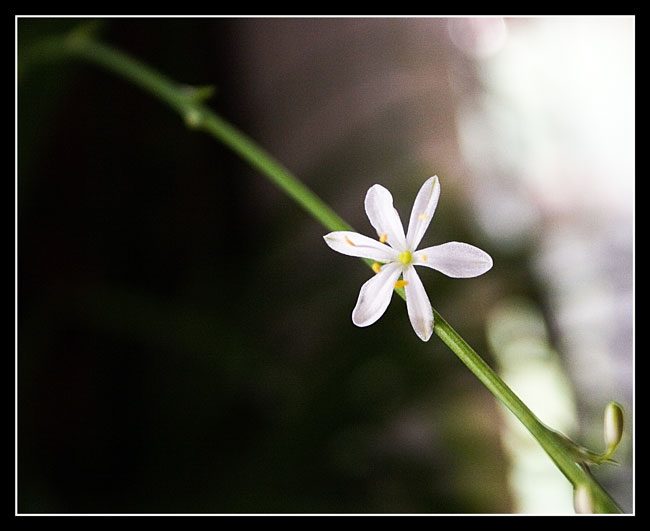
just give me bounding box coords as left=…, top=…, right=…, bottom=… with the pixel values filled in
left=352, top=263, right=402, bottom=326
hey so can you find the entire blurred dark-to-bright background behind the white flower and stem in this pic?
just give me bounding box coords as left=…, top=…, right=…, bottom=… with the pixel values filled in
left=17, top=17, right=635, bottom=514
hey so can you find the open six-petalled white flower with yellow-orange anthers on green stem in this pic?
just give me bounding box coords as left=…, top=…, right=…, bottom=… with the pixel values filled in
left=324, top=175, right=492, bottom=341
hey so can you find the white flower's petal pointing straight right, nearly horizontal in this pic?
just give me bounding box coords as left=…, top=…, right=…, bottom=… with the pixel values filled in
left=413, top=242, right=492, bottom=278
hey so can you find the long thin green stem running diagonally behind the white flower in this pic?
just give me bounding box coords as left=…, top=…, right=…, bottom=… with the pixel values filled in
left=19, top=32, right=622, bottom=513
